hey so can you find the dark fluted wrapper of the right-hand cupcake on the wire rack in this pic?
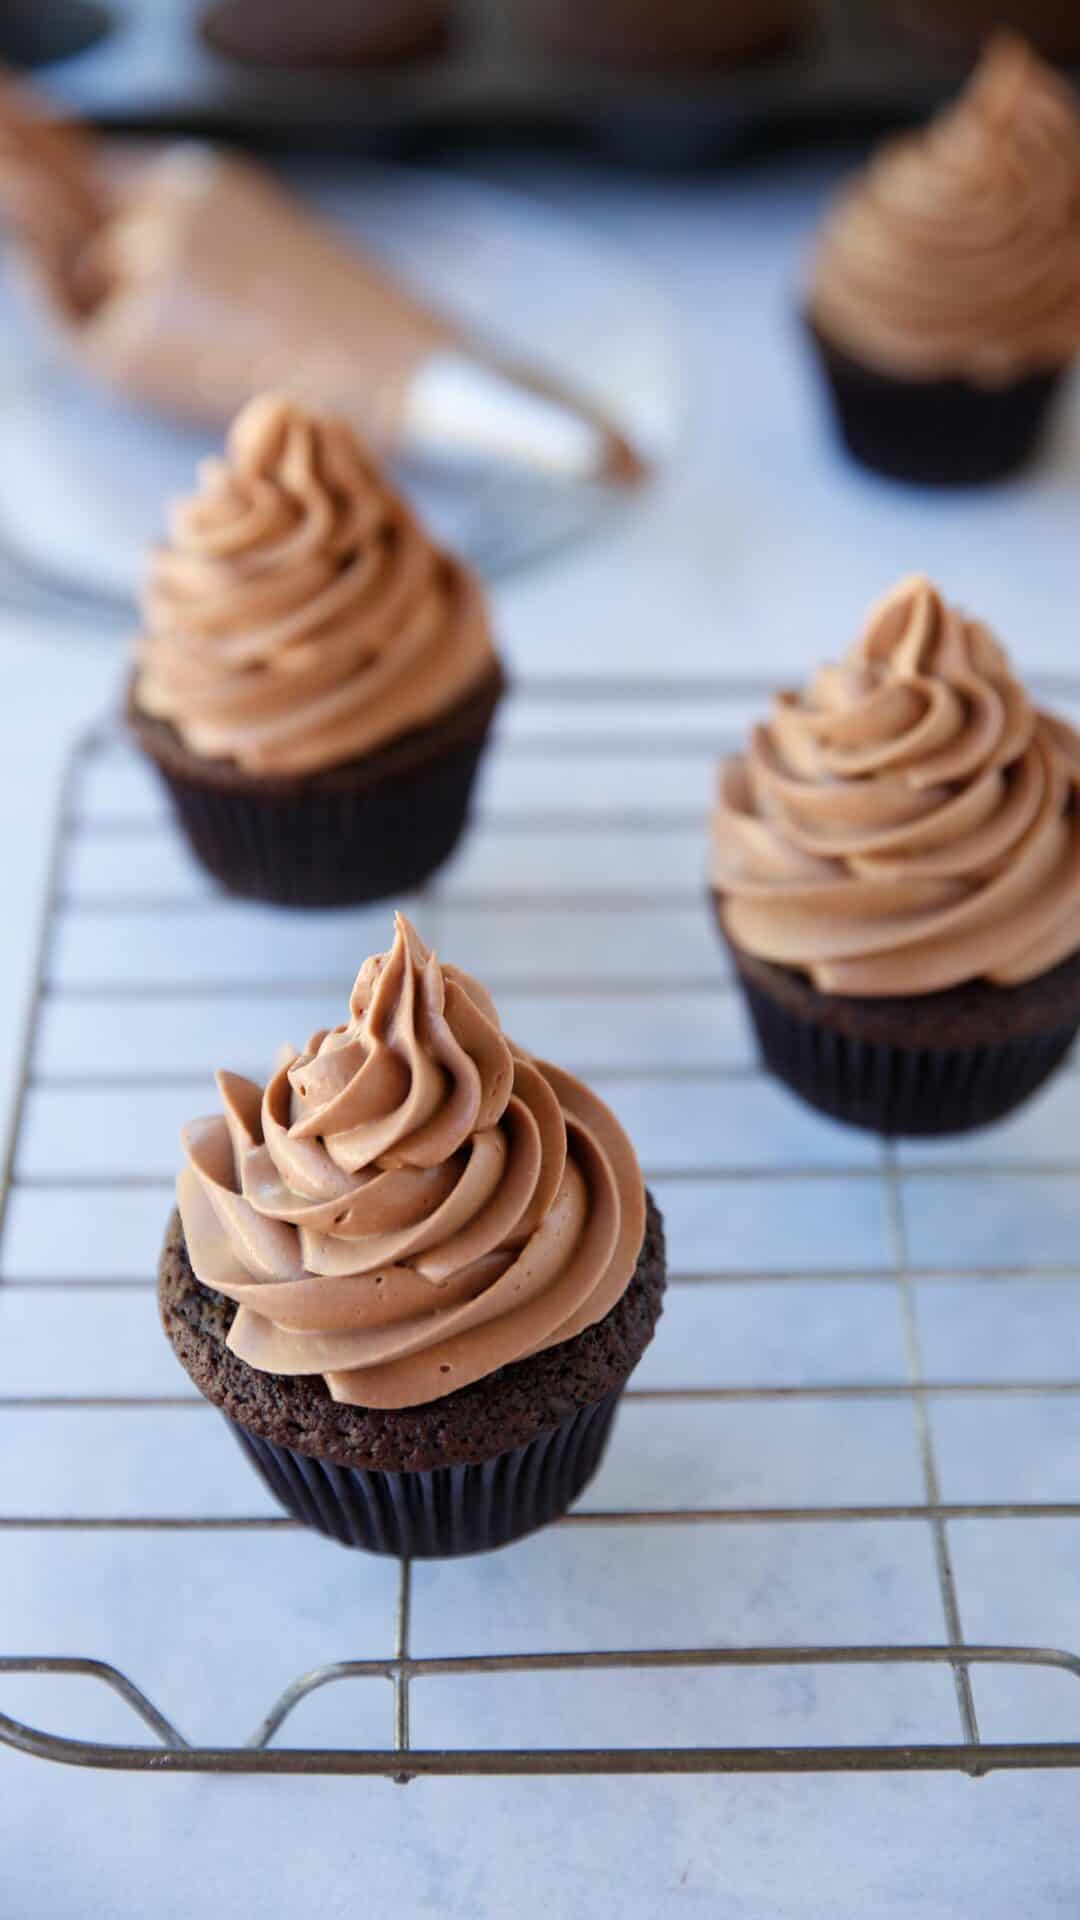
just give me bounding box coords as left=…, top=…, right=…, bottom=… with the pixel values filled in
left=742, top=975, right=1076, bottom=1137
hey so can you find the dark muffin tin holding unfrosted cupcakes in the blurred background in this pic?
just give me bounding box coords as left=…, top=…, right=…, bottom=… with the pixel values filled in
left=16, top=0, right=1068, bottom=161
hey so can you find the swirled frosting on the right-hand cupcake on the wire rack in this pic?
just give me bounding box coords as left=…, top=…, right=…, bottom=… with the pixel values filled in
left=711, top=578, right=1080, bottom=996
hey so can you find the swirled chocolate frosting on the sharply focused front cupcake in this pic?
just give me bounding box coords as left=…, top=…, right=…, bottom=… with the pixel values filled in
left=177, top=916, right=646, bottom=1407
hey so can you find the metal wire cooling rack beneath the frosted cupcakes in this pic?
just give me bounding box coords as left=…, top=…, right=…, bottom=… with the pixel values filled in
left=0, top=680, right=1080, bottom=1780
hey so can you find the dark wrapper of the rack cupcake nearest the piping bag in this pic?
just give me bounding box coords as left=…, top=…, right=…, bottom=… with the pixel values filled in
left=147, top=733, right=484, bottom=906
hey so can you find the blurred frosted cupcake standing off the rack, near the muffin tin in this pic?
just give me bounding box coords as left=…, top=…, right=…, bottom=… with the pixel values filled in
left=807, top=38, right=1080, bottom=486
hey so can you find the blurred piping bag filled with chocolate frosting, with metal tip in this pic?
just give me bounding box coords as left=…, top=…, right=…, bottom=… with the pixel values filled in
left=0, top=75, right=644, bottom=490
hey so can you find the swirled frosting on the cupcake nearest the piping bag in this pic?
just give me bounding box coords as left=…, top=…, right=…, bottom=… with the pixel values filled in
left=135, top=385, right=496, bottom=774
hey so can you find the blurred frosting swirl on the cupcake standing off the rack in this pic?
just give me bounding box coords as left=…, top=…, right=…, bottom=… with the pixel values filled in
left=809, top=36, right=1080, bottom=386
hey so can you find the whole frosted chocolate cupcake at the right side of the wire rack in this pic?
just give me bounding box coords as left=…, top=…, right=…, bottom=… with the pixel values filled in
left=711, top=578, right=1080, bottom=1135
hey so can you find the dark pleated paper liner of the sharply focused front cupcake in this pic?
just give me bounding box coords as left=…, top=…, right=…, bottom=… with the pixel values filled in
left=223, top=1388, right=623, bottom=1559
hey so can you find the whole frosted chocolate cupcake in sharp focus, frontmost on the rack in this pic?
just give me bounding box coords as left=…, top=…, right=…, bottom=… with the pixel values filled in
left=160, top=916, right=665, bottom=1555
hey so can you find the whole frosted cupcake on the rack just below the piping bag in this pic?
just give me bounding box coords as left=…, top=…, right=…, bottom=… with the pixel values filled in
left=127, top=396, right=502, bottom=906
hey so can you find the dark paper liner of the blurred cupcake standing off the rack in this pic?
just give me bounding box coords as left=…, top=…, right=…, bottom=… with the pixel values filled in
left=809, top=324, right=1065, bottom=486
